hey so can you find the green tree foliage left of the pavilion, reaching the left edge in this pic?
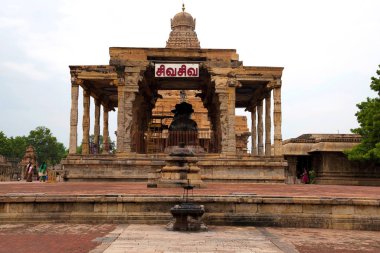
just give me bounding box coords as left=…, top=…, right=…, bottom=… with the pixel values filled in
left=0, top=127, right=67, bottom=165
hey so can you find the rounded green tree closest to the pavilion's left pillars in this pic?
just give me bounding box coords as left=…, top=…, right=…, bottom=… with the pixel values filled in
left=27, top=126, right=67, bottom=165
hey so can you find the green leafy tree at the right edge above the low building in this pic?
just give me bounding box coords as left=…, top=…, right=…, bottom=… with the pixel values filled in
left=346, top=65, right=380, bottom=163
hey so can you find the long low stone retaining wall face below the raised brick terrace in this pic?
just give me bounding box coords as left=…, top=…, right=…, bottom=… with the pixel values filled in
left=0, top=194, right=380, bottom=231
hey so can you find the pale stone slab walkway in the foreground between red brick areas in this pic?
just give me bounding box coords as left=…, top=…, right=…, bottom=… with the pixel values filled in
left=91, top=225, right=292, bottom=253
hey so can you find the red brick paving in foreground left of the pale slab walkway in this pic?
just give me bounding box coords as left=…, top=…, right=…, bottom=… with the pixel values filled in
left=0, top=224, right=116, bottom=253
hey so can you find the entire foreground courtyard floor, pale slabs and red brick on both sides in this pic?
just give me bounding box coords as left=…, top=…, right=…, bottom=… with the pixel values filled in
left=0, top=224, right=380, bottom=253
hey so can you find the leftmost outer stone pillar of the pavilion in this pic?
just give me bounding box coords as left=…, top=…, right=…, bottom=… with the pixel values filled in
left=69, top=78, right=82, bottom=154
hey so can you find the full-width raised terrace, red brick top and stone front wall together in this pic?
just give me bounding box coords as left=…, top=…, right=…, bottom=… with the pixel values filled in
left=0, top=182, right=380, bottom=231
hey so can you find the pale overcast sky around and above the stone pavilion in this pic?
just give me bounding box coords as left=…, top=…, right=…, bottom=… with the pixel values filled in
left=0, top=0, right=380, bottom=147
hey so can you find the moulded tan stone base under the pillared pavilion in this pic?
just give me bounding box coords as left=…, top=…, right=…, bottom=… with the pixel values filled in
left=62, top=154, right=287, bottom=183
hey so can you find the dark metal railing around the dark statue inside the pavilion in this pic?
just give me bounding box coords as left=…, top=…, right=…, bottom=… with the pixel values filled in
left=132, top=130, right=220, bottom=154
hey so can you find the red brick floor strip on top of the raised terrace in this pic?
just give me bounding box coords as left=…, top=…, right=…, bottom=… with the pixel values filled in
left=0, top=182, right=380, bottom=199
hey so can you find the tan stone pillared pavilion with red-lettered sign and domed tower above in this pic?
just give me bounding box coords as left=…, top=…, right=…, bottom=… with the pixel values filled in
left=62, top=8, right=287, bottom=182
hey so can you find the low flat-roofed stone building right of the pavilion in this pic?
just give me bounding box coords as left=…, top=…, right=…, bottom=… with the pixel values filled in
left=283, top=134, right=380, bottom=186
